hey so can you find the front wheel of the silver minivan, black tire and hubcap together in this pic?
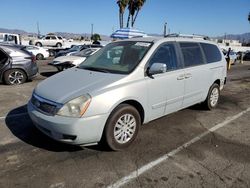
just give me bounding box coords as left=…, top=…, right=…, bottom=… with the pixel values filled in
left=103, top=104, right=141, bottom=151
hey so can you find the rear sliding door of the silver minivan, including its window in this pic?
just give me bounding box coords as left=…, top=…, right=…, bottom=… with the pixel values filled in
left=179, top=42, right=211, bottom=108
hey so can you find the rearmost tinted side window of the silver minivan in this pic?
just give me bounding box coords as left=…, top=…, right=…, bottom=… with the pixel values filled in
left=201, top=43, right=221, bottom=63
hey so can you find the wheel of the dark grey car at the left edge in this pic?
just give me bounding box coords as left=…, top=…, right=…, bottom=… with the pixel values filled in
left=4, top=69, right=27, bottom=85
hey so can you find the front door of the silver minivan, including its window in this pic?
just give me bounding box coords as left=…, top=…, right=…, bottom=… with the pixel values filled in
left=146, top=43, right=185, bottom=120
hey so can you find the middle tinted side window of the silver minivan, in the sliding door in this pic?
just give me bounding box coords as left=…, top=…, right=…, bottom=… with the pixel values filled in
left=180, top=42, right=204, bottom=67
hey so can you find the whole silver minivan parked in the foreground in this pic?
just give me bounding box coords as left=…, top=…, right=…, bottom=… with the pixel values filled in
left=28, top=37, right=227, bottom=150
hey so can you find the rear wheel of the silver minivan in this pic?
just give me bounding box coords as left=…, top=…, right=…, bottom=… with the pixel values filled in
left=203, top=83, right=220, bottom=110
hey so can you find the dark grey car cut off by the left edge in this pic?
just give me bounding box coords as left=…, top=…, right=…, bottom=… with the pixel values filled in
left=0, top=44, right=38, bottom=85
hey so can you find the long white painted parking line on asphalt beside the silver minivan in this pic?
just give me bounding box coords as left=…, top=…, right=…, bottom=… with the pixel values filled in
left=108, top=108, right=250, bottom=188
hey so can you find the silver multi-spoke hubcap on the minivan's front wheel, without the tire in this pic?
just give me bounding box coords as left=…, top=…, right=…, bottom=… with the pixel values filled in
left=114, top=114, right=136, bottom=144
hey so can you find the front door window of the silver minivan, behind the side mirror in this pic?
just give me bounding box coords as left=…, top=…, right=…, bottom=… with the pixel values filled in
left=149, top=44, right=177, bottom=71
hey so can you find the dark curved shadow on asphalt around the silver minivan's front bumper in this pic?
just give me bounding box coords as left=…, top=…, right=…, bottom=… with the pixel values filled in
left=5, top=105, right=83, bottom=152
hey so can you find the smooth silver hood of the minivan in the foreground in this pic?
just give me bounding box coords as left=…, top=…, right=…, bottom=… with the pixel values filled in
left=34, top=68, right=125, bottom=104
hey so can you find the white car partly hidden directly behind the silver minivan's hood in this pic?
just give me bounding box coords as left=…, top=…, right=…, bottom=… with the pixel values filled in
left=49, top=48, right=101, bottom=71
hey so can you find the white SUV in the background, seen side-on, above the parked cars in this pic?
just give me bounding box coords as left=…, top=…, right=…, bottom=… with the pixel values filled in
left=33, top=35, right=64, bottom=47
